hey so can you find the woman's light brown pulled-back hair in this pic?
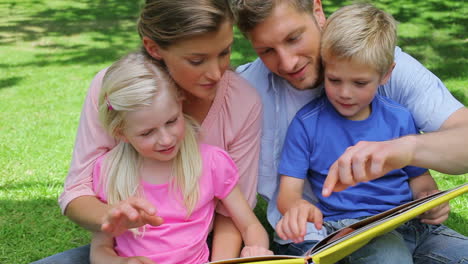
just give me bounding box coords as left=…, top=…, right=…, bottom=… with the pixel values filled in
left=138, top=0, right=233, bottom=48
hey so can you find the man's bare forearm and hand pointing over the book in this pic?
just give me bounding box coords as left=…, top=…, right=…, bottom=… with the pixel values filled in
left=323, top=107, right=468, bottom=196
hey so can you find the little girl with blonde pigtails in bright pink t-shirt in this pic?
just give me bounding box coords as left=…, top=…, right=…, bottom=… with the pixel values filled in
left=91, top=50, right=272, bottom=264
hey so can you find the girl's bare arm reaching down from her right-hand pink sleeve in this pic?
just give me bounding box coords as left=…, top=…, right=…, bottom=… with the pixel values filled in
left=222, top=187, right=273, bottom=257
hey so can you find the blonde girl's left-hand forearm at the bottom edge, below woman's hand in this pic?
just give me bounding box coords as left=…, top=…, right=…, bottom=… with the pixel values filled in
left=90, top=232, right=156, bottom=264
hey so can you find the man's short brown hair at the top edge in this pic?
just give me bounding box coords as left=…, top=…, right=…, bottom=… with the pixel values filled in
left=232, top=0, right=315, bottom=36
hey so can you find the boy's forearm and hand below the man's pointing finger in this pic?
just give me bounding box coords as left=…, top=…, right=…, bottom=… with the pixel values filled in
left=275, top=175, right=323, bottom=243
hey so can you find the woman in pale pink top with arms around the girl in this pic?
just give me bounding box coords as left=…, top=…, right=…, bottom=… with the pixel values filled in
left=36, top=0, right=261, bottom=264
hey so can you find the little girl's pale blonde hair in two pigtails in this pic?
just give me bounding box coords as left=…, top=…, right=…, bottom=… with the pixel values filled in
left=99, top=52, right=202, bottom=216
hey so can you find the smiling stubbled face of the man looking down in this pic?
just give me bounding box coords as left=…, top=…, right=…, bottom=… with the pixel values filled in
left=248, top=1, right=325, bottom=90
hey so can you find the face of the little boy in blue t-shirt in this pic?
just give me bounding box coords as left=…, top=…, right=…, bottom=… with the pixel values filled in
left=324, top=56, right=390, bottom=120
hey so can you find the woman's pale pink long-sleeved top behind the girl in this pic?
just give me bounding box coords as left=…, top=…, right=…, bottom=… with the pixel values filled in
left=59, top=69, right=262, bottom=214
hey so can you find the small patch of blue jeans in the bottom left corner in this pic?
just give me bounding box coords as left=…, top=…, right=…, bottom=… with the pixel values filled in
left=30, top=245, right=89, bottom=264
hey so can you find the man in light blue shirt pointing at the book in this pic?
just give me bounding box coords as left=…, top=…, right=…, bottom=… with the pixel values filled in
left=234, top=0, right=468, bottom=260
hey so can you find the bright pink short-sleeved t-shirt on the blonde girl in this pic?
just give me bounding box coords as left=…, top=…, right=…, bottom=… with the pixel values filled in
left=93, top=144, right=239, bottom=264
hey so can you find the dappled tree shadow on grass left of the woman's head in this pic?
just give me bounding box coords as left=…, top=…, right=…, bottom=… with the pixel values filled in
left=0, top=0, right=142, bottom=68
